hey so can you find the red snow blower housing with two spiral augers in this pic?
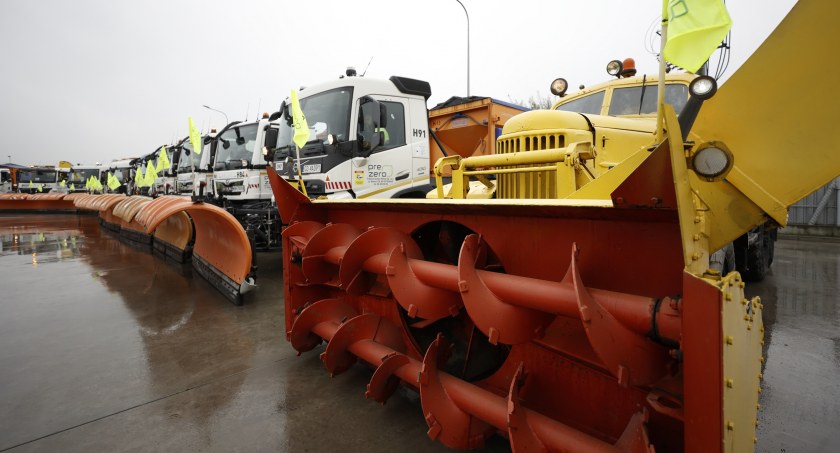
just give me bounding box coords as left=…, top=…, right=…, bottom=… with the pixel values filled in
left=269, top=133, right=760, bottom=452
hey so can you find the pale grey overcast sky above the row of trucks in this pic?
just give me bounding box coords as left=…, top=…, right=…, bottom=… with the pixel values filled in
left=0, top=0, right=795, bottom=165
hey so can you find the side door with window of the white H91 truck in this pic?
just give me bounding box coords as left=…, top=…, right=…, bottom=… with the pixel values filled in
left=350, top=96, right=412, bottom=198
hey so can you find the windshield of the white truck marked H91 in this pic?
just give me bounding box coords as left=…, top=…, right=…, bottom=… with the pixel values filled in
left=277, top=87, right=353, bottom=152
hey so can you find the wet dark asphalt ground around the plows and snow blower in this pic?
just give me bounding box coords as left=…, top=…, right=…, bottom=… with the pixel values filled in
left=0, top=215, right=840, bottom=452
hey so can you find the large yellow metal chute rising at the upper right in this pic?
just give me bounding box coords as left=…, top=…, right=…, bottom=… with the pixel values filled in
left=692, top=0, right=840, bottom=249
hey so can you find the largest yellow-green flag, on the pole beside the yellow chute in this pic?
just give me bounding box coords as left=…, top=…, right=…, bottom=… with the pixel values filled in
left=663, top=0, right=732, bottom=72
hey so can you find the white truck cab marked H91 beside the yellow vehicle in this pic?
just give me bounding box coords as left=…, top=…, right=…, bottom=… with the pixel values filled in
left=273, top=70, right=432, bottom=198
